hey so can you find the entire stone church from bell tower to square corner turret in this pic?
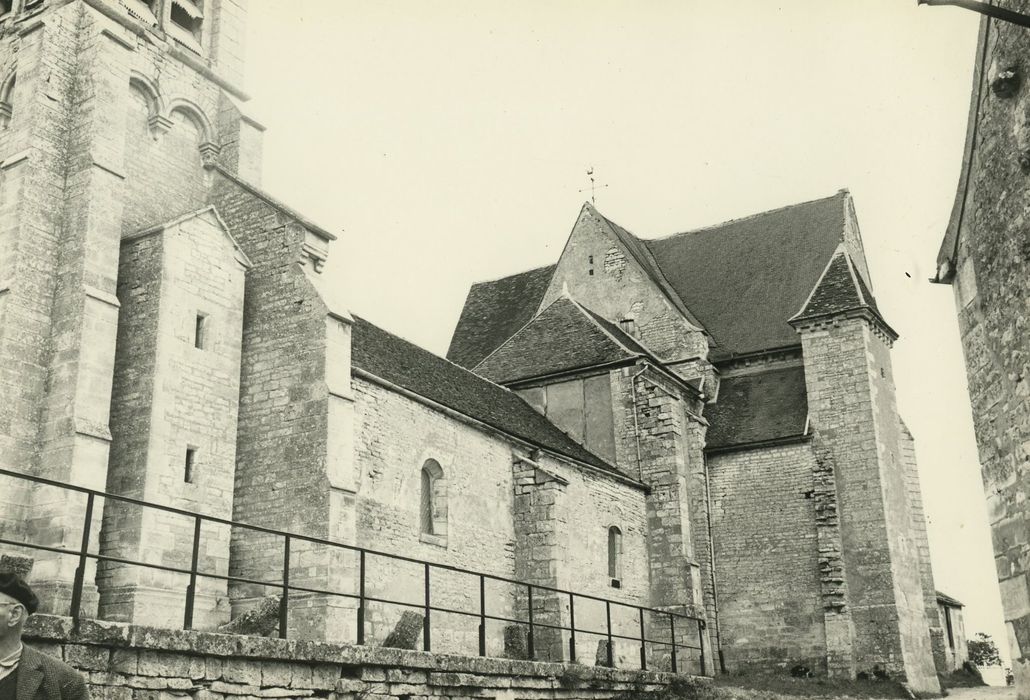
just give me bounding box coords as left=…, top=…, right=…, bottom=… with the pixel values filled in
left=0, top=0, right=943, bottom=691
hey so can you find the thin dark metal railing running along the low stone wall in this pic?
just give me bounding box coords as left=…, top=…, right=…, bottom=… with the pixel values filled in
left=0, top=469, right=708, bottom=675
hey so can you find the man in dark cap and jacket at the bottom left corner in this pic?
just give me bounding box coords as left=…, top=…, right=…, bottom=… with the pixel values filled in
left=0, top=573, right=90, bottom=700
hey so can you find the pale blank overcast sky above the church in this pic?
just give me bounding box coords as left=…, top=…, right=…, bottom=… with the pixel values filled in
left=247, top=0, right=1007, bottom=651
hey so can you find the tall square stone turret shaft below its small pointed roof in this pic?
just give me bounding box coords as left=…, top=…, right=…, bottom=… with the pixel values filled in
left=801, top=318, right=938, bottom=692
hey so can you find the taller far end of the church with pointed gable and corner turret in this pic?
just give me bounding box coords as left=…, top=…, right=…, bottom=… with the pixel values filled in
left=448, top=198, right=945, bottom=691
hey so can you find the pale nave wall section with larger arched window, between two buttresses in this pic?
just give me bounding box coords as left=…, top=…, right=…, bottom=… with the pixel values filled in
left=353, top=379, right=515, bottom=655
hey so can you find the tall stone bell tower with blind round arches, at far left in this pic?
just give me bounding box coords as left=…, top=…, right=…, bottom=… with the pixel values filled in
left=0, top=0, right=262, bottom=614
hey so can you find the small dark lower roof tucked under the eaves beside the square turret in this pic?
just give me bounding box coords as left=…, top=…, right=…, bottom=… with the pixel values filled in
left=705, top=366, right=809, bottom=450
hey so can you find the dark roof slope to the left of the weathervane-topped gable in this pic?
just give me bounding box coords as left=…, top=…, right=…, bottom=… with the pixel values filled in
left=447, top=265, right=555, bottom=368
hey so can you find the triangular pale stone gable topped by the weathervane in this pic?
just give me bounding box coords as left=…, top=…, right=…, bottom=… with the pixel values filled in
left=541, top=205, right=708, bottom=360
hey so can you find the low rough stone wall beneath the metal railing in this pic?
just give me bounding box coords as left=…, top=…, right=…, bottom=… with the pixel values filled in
left=25, top=615, right=700, bottom=700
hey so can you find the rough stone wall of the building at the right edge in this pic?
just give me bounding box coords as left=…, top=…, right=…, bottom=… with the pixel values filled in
left=948, top=5, right=1030, bottom=697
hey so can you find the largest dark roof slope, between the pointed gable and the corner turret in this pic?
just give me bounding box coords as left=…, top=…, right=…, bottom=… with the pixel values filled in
left=646, top=191, right=846, bottom=354
